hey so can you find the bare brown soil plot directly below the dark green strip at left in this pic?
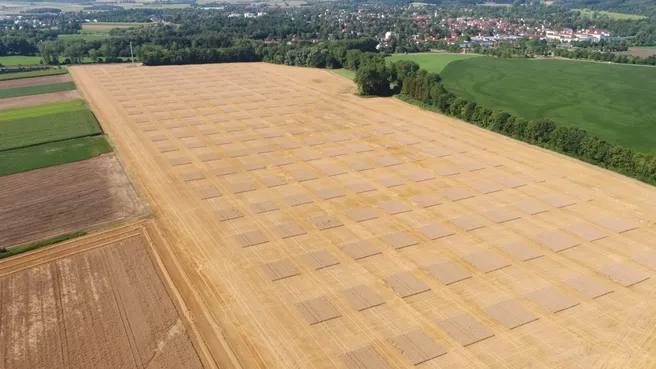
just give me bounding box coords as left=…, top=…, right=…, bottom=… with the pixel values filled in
left=0, top=155, right=144, bottom=247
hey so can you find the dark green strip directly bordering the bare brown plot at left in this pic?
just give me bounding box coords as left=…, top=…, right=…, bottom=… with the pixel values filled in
left=0, top=136, right=112, bottom=176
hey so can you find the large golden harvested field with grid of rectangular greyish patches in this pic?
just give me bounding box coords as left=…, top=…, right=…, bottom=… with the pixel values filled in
left=71, top=64, right=656, bottom=369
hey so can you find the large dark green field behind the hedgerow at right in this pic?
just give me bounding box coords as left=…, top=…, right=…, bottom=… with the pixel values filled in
left=441, top=58, right=656, bottom=154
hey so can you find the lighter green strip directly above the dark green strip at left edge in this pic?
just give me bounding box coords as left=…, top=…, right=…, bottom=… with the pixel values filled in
left=0, top=109, right=102, bottom=151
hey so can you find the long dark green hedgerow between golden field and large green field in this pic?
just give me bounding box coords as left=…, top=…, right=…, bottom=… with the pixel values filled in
left=399, top=61, right=656, bottom=184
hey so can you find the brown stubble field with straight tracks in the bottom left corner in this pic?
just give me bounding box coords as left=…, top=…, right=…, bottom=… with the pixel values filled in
left=0, top=223, right=208, bottom=369
